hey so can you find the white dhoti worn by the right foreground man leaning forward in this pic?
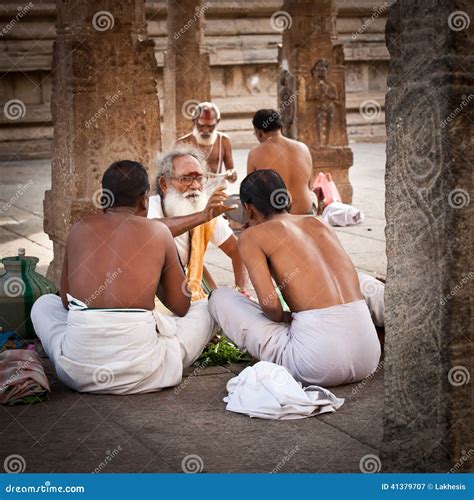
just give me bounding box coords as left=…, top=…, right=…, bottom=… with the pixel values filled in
left=209, top=288, right=380, bottom=387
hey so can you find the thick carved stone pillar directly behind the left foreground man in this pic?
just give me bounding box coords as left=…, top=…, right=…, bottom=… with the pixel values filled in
left=44, top=0, right=160, bottom=284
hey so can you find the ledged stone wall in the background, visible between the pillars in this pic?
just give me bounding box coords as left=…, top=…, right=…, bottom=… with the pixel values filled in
left=0, top=0, right=389, bottom=160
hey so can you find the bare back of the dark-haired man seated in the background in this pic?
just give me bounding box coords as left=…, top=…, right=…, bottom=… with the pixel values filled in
left=247, top=134, right=313, bottom=215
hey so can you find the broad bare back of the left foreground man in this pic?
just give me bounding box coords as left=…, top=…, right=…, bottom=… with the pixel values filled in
left=61, top=213, right=189, bottom=314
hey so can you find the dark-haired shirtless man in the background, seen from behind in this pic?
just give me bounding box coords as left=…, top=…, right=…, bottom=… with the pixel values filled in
left=247, top=109, right=314, bottom=215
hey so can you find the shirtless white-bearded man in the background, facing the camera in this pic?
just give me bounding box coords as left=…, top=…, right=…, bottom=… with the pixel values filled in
left=176, top=102, right=237, bottom=194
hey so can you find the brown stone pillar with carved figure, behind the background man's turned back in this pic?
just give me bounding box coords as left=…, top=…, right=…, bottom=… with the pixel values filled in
left=280, top=0, right=352, bottom=203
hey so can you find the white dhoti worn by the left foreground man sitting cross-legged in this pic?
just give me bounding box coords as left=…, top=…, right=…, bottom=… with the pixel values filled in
left=31, top=294, right=214, bottom=394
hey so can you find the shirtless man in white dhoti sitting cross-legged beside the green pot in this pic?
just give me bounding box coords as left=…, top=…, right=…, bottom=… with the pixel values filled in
left=31, top=161, right=214, bottom=394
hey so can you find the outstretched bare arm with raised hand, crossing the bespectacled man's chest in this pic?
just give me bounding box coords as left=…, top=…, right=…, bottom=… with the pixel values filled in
left=151, top=187, right=237, bottom=238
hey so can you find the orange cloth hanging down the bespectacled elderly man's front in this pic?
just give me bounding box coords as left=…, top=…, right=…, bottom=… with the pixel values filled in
left=186, top=219, right=216, bottom=301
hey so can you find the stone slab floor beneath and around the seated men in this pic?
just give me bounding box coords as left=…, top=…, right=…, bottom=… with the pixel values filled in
left=0, top=144, right=386, bottom=472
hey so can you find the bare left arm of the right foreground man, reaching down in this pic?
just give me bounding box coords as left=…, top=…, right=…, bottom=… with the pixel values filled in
left=239, top=229, right=289, bottom=323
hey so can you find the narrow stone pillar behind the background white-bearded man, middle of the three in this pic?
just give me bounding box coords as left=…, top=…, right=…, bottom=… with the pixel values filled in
left=163, top=0, right=211, bottom=149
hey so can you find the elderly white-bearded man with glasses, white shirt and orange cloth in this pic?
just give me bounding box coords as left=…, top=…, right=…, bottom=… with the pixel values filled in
left=148, top=144, right=248, bottom=300
